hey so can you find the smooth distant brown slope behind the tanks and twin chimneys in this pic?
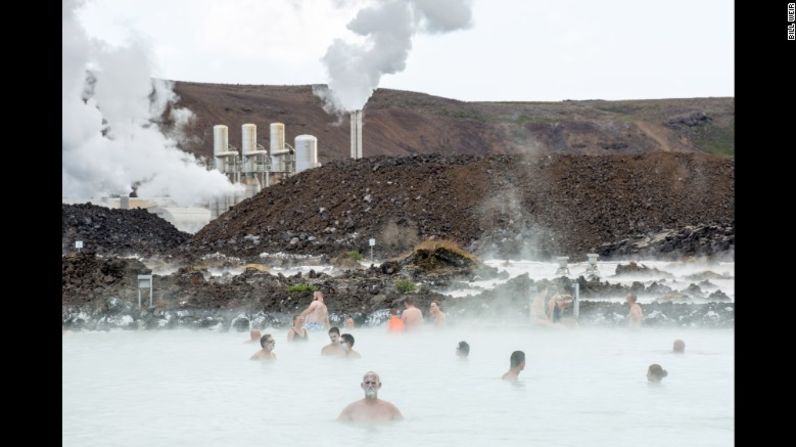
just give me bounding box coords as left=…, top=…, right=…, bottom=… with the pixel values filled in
left=168, top=82, right=735, bottom=162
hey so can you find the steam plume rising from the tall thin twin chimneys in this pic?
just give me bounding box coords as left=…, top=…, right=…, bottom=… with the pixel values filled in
left=317, top=0, right=472, bottom=112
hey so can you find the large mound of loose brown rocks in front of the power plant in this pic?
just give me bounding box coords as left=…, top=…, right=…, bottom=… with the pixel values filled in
left=186, top=152, right=735, bottom=258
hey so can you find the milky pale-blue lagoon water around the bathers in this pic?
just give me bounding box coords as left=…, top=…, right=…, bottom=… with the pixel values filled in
left=63, top=321, right=734, bottom=447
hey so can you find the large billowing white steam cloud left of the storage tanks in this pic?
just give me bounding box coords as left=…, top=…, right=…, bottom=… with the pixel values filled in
left=62, top=0, right=236, bottom=206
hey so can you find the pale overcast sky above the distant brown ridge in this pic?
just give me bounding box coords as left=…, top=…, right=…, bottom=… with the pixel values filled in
left=78, top=0, right=734, bottom=101
